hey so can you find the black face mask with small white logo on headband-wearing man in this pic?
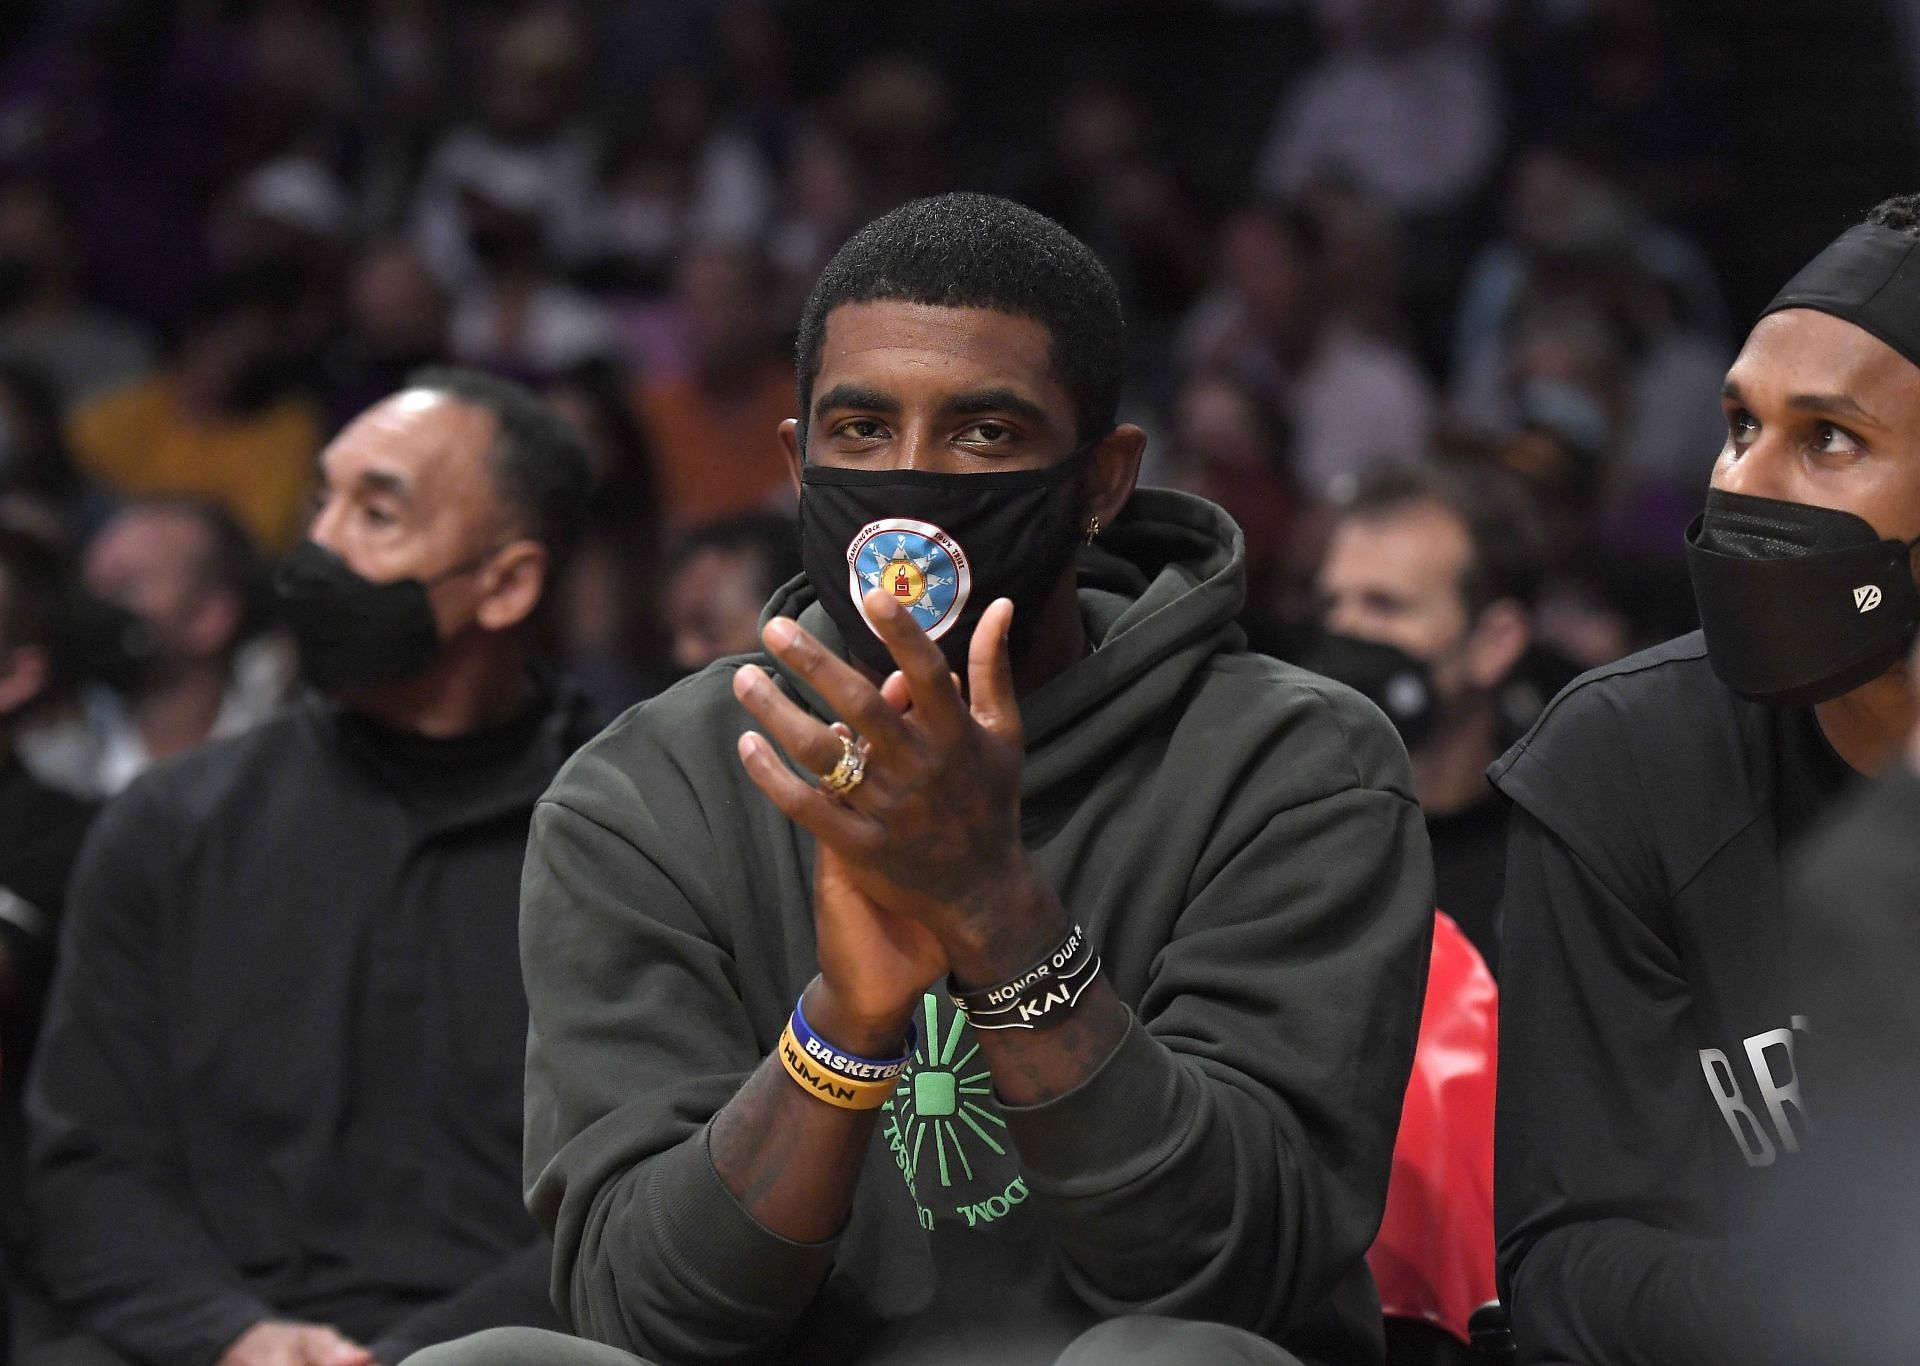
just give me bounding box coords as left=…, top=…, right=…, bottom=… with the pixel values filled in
left=1686, top=488, right=1920, bottom=707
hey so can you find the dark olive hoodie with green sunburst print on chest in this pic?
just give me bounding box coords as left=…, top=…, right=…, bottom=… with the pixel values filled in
left=520, top=490, right=1432, bottom=1366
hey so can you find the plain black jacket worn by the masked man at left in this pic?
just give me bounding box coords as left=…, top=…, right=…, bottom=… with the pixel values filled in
left=27, top=687, right=586, bottom=1366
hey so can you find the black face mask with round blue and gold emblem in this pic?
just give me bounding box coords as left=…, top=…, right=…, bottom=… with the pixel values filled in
left=801, top=446, right=1092, bottom=678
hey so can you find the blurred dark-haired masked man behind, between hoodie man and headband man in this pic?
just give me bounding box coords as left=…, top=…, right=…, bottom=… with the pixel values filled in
left=1308, top=465, right=1542, bottom=970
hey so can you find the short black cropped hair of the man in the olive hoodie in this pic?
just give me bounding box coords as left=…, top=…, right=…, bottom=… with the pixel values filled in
left=793, top=194, right=1125, bottom=444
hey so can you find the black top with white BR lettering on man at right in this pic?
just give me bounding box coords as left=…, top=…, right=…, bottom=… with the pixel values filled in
left=1490, top=634, right=1849, bottom=1366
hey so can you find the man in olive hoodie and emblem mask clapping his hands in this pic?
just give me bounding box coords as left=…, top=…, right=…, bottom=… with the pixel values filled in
left=422, top=196, right=1432, bottom=1366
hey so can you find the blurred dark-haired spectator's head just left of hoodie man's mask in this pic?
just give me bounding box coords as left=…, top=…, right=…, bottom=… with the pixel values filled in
left=666, top=513, right=801, bottom=672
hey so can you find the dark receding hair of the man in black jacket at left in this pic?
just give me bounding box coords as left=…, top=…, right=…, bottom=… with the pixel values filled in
left=407, top=365, right=593, bottom=584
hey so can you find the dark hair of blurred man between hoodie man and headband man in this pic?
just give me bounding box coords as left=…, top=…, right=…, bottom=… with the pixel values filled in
left=1336, top=465, right=1546, bottom=617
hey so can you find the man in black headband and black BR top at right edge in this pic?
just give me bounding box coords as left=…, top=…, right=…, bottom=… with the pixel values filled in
left=1490, top=196, right=1920, bottom=1366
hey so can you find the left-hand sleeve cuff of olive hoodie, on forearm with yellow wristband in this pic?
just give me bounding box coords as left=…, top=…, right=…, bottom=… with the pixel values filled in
left=651, top=1130, right=839, bottom=1316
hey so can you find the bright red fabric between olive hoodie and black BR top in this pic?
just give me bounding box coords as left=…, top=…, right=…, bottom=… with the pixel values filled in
left=1367, top=913, right=1500, bottom=1343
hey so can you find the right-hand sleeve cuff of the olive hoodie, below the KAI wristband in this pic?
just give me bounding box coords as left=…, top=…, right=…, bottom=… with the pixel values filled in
left=1000, top=1018, right=1200, bottom=1199
